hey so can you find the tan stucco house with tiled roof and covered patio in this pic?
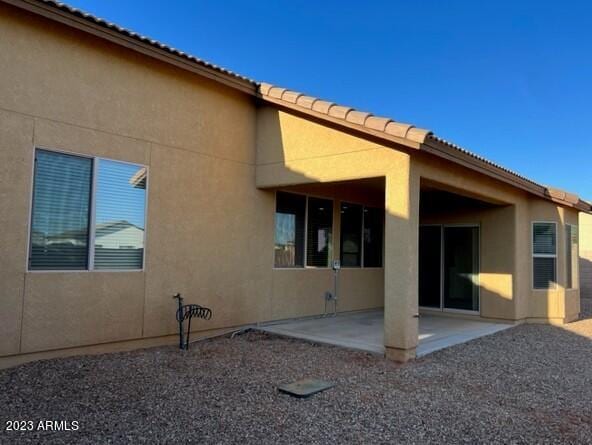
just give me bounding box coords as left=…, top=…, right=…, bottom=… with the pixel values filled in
left=0, top=0, right=592, bottom=366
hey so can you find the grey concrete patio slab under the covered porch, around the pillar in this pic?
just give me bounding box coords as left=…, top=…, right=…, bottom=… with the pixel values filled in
left=259, top=310, right=513, bottom=357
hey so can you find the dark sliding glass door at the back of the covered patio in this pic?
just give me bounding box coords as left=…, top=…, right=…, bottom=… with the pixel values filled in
left=419, top=225, right=479, bottom=312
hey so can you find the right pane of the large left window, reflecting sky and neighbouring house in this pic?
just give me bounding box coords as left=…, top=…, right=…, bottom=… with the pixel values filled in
left=94, top=159, right=146, bottom=269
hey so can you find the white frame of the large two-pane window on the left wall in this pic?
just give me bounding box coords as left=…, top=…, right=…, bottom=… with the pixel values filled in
left=25, top=145, right=150, bottom=273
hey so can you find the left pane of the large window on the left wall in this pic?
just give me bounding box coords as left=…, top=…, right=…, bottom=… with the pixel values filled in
left=29, top=150, right=92, bottom=270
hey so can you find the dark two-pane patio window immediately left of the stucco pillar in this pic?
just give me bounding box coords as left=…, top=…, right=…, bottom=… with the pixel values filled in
left=341, top=202, right=384, bottom=267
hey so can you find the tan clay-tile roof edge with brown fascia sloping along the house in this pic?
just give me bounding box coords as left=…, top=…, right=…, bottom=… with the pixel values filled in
left=0, top=0, right=592, bottom=212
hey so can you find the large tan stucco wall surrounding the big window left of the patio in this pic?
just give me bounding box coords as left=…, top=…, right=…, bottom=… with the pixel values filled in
left=0, top=5, right=275, bottom=355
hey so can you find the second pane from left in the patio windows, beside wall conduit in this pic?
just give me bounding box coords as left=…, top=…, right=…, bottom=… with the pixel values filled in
left=306, top=198, right=333, bottom=267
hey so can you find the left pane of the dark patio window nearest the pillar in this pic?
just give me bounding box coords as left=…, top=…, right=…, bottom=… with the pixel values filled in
left=341, top=202, right=363, bottom=267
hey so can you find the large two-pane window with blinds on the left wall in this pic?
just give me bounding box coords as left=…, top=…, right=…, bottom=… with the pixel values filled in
left=29, top=150, right=147, bottom=270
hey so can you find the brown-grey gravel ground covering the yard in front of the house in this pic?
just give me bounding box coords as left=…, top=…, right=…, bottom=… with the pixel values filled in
left=0, top=301, right=592, bottom=444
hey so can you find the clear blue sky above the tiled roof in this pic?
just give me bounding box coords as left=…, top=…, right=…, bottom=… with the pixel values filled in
left=69, top=0, right=592, bottom=200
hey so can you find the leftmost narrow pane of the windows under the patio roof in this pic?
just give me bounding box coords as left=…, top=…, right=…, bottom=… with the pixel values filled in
left=274, top=192, right=306, bottom=267
